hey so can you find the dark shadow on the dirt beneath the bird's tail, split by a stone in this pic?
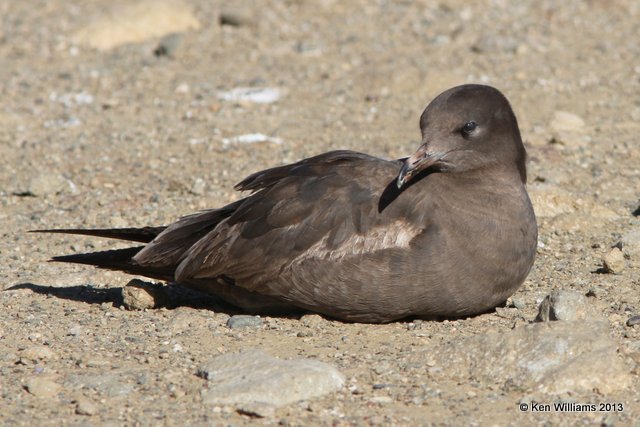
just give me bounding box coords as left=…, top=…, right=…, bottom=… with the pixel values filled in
left=5, top=283, right=238, bottom=314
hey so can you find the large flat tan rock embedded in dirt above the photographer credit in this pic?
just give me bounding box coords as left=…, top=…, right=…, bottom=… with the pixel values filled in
left=413, top=321, right=632, bottom=395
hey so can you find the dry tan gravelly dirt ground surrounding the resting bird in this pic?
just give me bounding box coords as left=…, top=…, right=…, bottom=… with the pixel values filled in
left=0, top=0, right=640, bottom=425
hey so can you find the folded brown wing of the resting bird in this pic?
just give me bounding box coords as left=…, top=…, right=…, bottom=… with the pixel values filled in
left=135, top=151, right=410, bottom=293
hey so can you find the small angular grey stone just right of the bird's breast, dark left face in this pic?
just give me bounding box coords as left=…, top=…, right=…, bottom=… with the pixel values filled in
left=535, top=290, right=604, bottom=322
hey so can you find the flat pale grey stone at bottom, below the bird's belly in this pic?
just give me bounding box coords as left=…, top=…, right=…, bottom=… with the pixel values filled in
left=199, top=349, right=345, bottom=408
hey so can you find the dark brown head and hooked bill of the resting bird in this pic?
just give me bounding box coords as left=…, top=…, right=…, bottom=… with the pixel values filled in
left=397, top=84, right=526, bottom=188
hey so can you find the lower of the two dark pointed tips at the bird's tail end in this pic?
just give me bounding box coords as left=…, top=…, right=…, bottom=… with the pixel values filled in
left=51, top=246, right=174, bottom=281
